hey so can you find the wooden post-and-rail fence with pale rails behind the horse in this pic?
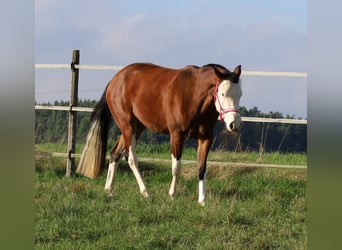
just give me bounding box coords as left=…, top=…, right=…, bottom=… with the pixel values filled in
left=35, top=50, right=307, bottom=176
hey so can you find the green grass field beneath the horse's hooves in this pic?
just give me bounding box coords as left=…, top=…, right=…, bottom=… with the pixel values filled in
left=35, top=146, right=307, bottom=249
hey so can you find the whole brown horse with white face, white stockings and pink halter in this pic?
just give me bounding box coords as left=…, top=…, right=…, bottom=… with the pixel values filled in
left=77, top=63, right=242, bottom=204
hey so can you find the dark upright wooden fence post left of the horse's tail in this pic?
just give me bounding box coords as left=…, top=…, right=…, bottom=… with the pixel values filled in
left=66, top=50, right=80, bottom=177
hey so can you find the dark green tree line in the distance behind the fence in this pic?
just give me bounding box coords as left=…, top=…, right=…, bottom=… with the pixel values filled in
left=35, top=99, right=307, bottom=153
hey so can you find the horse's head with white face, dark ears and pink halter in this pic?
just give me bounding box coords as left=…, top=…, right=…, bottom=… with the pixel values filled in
left=214, top=65, right=242, bottom=132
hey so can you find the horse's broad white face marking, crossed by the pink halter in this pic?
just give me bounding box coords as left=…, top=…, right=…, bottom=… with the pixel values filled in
left=215, top=80, right=242, bottom=131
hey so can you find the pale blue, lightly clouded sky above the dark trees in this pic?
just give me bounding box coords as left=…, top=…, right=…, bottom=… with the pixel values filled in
left=35, top=0, right=307, bottom=118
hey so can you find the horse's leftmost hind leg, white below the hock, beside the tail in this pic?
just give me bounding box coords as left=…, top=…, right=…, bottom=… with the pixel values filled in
left=105, top=136, right=125, bottom=195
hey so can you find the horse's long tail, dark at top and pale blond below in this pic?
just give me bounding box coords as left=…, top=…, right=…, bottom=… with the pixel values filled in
left=76, top=88, right=112, bottom=179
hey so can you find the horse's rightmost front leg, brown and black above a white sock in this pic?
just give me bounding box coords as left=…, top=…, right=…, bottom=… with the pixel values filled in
left=197, top=137, right=213, bottom=206
